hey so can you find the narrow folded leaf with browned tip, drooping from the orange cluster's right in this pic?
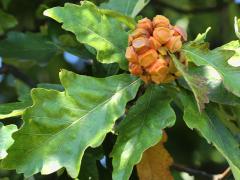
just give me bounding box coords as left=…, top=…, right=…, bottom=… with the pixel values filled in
left=171, top=54, right=209, bottom=111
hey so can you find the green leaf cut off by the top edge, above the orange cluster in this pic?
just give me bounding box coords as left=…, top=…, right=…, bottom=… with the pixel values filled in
left=100, top=0, right=150, bottom=18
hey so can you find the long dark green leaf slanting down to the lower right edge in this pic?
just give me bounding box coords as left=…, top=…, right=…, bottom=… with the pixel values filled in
left=179, top=90, right=240, bottom=179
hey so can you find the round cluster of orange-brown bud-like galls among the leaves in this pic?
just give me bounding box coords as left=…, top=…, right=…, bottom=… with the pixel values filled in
left=125, top=15, right=187, bottom=84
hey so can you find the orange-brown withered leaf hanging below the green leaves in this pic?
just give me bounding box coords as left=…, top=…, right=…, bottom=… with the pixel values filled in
left=137, top=133, right=173, bottom=180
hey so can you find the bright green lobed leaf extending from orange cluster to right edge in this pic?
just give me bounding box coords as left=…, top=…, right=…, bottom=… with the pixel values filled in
left=183, top=32, right=240, bottom=96
